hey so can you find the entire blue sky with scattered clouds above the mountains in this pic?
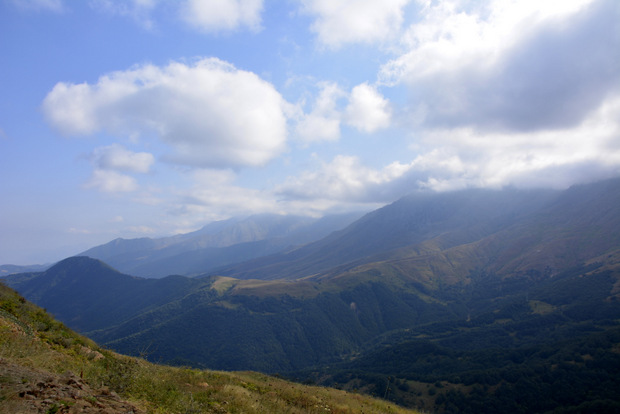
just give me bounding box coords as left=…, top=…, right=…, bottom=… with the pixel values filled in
left=0, top=0, right=620, bottom=264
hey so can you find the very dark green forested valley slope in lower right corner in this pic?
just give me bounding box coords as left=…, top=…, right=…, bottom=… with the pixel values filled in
left=291, top=265, right=620, bottom=413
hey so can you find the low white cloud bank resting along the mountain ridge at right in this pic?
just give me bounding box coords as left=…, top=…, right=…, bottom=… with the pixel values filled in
left=274, top=93, right=620, bottom=204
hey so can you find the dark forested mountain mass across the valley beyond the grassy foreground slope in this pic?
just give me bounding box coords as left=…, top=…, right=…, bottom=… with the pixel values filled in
left=4, top=179, right=620, bottom=412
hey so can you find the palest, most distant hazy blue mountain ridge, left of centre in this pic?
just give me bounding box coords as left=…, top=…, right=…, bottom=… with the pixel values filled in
left=79, top=213, right=362, bottom=278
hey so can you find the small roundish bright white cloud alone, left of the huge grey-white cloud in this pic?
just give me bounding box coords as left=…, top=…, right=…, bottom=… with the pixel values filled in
left=346, top=83, right=391, bottom=133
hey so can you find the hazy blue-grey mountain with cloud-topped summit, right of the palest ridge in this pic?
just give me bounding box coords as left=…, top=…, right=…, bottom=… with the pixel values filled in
left=218, top=189, right=558, bottom=279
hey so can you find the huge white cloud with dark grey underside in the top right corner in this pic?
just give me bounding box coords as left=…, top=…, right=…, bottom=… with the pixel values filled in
left=380, top=0, right=620, bottom=131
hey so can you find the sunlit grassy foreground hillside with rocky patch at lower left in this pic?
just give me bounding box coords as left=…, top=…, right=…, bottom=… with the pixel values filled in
left=0, top=285, right=413, bottom=414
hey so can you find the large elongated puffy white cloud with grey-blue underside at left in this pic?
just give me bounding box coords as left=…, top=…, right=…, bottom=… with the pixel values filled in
left=43, top=58, right=289, bottom=168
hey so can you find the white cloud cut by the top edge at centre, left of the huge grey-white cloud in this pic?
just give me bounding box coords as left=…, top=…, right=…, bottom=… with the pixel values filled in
left=302, top=0, right=410, bottom=48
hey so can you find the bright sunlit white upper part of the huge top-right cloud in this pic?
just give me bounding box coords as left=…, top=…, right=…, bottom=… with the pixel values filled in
left=382, top=0, right=593, bottom=83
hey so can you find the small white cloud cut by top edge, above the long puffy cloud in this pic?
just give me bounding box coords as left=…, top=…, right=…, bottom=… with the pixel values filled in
left=181, top=0, right=263, bottom=32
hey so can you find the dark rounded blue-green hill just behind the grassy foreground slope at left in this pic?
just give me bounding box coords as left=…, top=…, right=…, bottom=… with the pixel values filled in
left=5, top=256, right=206, bottom=332
